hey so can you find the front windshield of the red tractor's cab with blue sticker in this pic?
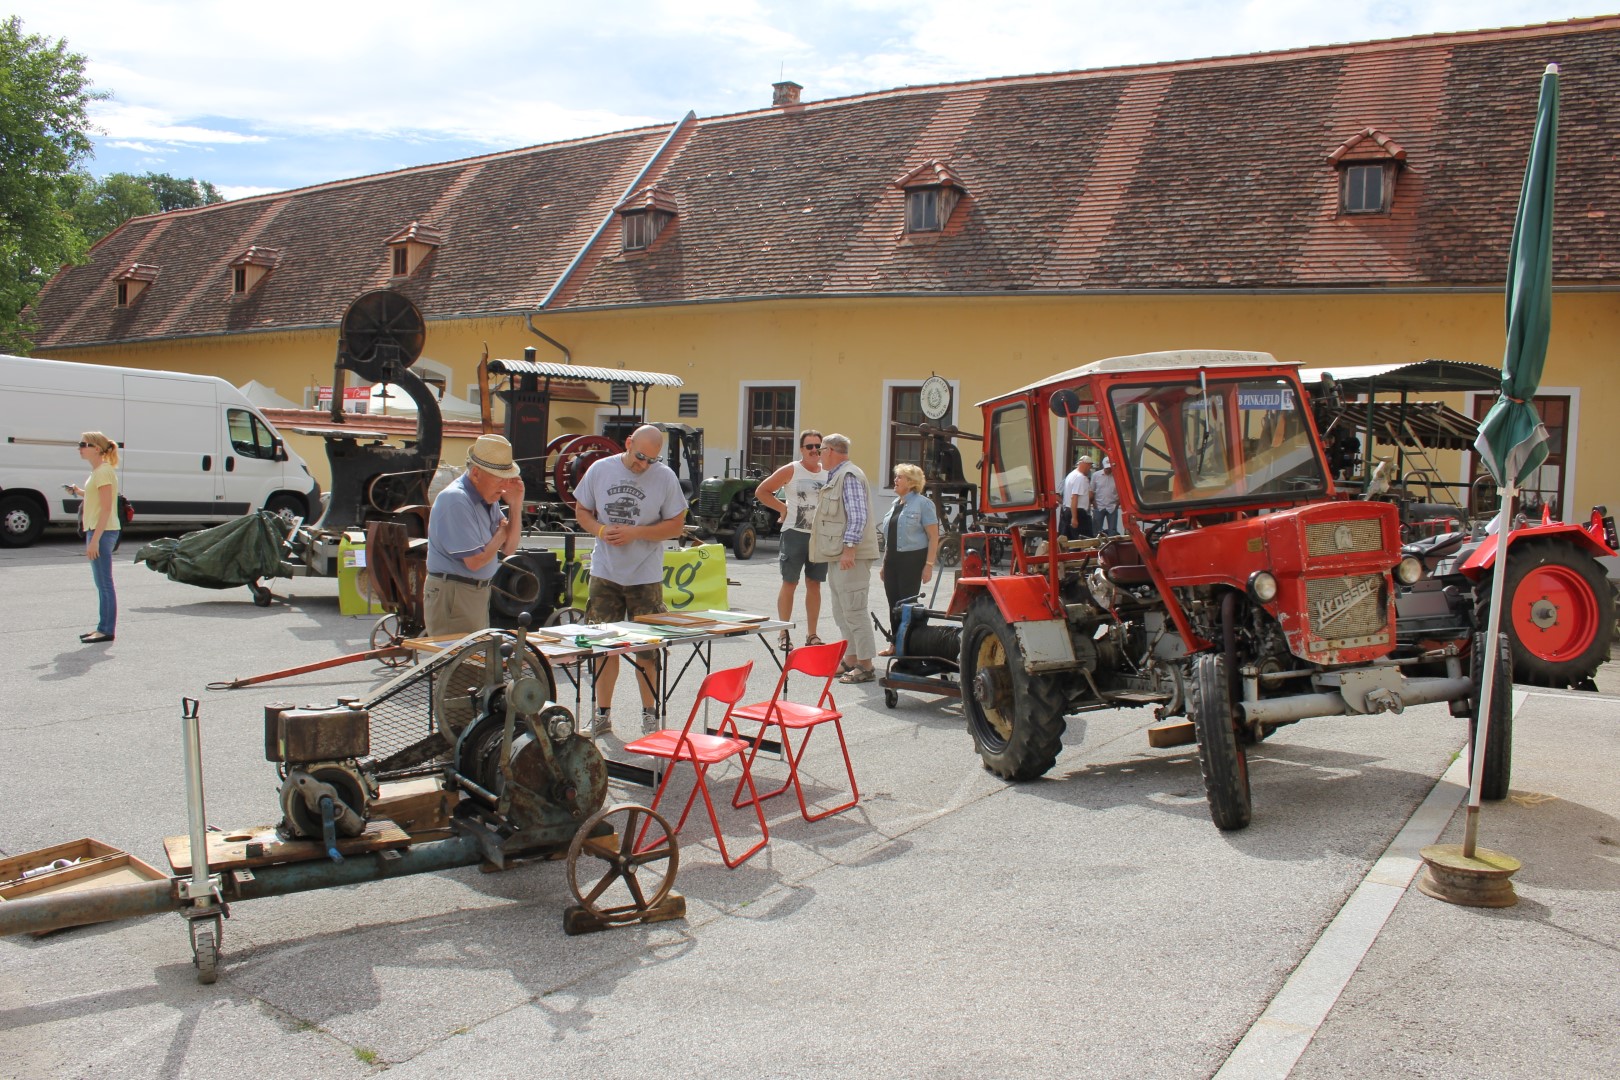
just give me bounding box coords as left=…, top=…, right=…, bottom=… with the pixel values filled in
left=1108, top=377, right=1327, bottom=508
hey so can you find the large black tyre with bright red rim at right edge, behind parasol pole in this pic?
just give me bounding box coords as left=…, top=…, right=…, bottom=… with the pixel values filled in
left=1477, top=539, right=1615, bottom=687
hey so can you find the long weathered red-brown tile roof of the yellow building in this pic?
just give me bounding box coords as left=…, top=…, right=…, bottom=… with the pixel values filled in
left=28, top=16, right=1620, bottom=348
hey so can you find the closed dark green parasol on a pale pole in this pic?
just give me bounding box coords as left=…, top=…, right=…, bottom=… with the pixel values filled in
left=1463, top=63, right=1558, bottom=858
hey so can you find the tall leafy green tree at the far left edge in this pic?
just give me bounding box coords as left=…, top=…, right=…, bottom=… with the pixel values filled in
left=0, top=15, right=100, bottom=353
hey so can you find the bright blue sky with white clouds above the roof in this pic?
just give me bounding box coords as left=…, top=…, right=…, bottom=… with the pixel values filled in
left=9, top=0, right=1614, bottom=198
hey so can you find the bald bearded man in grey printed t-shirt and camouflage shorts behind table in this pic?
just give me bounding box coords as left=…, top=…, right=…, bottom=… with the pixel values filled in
left=573, top=424, right=687, bottom=735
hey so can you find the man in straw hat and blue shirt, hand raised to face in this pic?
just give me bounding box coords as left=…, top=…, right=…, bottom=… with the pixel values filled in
left=421, top=436, right=523, bottom=638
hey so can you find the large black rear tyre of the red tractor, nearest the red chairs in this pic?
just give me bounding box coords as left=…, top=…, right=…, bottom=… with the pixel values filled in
left=962, top=596, right=1066, bottom=780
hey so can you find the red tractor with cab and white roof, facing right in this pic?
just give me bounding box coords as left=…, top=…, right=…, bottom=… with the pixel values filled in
left=949, top=351, right=1511, bottom=829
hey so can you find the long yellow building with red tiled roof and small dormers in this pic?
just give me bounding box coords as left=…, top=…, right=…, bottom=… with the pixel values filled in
left=28, top=18, right=1620, bottom=515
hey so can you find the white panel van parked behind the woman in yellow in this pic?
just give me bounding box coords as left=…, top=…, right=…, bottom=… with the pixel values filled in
left=0, top=355, right=321, bottom=547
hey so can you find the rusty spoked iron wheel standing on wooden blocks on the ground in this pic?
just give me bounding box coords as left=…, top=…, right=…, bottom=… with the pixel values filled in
left=567, top=803, right=680, bottom=925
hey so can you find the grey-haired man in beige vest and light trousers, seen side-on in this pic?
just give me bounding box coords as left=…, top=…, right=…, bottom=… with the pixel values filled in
left=810, top=434, right=878, bottom=683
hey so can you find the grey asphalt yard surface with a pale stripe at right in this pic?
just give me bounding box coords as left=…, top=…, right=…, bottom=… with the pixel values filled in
left=0, top=527, right=1620, bottom=1077
